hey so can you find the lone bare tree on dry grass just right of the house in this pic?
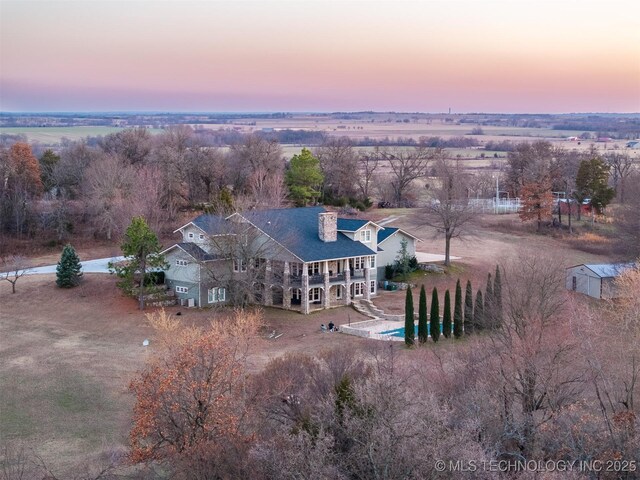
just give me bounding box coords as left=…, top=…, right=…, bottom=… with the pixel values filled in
left=420, top=157, right=474, bottom=266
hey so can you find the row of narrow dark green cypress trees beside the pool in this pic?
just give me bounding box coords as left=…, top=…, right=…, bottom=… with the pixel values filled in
left=404, top=266, right=502, bottom=346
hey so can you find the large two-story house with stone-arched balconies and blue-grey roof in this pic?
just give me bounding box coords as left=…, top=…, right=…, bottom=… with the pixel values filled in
left=163, top=207, right=417, bottom=314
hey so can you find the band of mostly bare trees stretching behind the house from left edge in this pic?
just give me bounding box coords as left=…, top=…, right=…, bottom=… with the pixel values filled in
left=0, top=125, right=444, bottom=242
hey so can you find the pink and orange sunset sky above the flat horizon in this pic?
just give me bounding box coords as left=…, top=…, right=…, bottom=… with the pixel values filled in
left=0, top=0, right=640, bottom=113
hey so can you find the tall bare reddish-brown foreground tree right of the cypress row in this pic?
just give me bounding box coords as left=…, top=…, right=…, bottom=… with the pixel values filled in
left=491, top=252, right=586, bottom=459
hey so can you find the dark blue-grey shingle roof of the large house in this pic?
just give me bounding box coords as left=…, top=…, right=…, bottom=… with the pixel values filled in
left=192, top=207, right=375, bottom=262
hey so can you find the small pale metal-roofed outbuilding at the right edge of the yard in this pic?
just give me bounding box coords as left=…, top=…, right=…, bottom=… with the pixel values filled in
left=566, top=263, right=635, bottom=299
